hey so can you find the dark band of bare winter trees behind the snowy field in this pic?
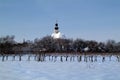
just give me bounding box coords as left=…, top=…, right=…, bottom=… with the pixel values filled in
left=0, top=35, right=120, bottom=54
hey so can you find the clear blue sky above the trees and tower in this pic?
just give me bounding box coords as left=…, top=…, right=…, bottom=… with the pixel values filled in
left=0, top=0, right=120, bottom=41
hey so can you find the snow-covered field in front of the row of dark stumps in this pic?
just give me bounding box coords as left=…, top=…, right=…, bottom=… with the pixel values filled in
left=0, top=56, right=120, bottom=80
